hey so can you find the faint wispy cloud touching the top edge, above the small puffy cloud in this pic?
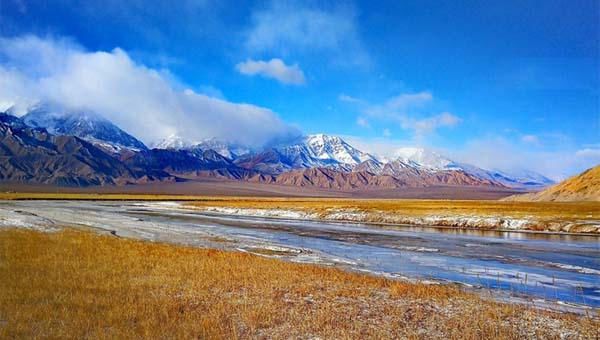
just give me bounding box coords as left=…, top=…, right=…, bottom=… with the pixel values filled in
left=246, top=1, right=369, bottom=64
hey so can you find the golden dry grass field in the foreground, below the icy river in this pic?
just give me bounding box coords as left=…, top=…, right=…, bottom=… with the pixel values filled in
left=0, top=229, right=600, bottom=339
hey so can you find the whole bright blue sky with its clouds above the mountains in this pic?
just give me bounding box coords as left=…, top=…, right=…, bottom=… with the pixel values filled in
left=0, top=0, right=600, bottom=177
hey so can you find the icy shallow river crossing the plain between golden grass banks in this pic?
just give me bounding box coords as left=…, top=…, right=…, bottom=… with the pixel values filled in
left=0, top=201, right=600, bottom=307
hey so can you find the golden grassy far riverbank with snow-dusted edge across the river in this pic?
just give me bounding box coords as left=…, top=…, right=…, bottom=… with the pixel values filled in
left=186, top=198, right=600, bottom=235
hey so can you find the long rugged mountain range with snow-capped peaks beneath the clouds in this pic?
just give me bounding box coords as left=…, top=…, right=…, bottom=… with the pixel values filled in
left=0, top=103, right=554, bottom=190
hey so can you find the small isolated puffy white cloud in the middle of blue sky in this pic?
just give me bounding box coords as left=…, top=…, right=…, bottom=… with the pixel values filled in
left=235, top=58, right=306, bottom=85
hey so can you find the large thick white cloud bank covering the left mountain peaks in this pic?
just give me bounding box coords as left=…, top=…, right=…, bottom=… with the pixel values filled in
left=0, top=36, right=296, bottom=145
